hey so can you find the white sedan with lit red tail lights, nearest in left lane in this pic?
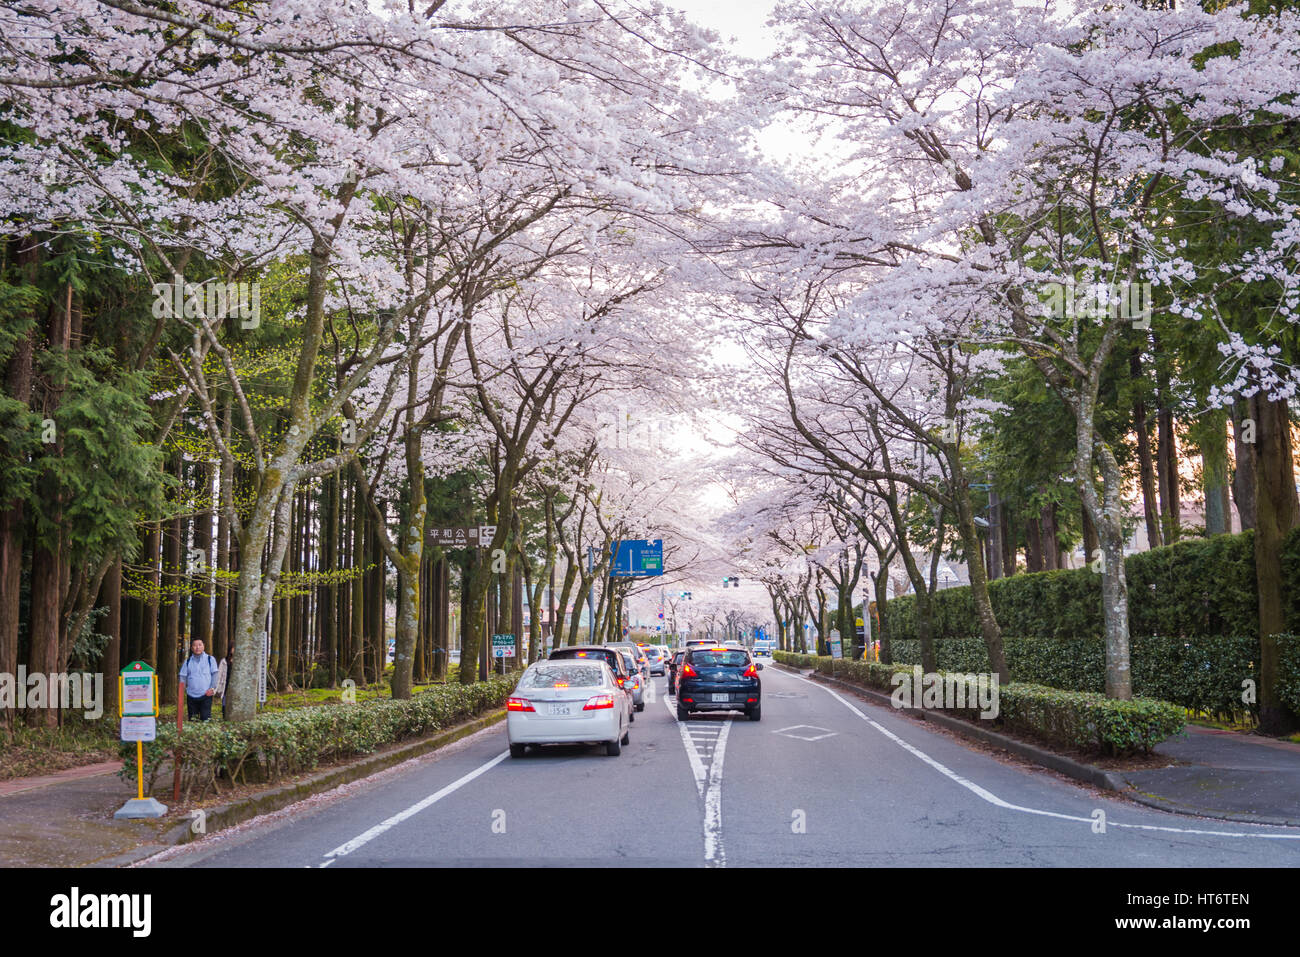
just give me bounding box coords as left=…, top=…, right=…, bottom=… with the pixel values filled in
left=506, top=658, right=632, bottom=758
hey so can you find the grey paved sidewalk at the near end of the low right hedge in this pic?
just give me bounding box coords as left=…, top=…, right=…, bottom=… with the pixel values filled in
left=1123, top=724, right=1300, bottom=827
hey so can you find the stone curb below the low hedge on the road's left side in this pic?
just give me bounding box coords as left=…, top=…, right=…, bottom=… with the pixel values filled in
left=109, top=709, right=506, bottom=867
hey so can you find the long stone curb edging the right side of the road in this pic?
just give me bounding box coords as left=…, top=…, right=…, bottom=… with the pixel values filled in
left=772, top=662, right=1300, bottom=827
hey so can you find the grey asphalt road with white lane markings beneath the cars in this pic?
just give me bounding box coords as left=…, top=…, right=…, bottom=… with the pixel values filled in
left=147, top=666, right=1300, bottom=867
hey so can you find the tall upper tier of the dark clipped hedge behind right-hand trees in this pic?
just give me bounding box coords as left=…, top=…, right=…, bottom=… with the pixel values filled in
left=885, top=529, right=1300, bottom=640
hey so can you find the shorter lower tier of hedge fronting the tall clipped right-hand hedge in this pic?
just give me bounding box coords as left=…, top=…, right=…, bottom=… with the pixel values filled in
left=892, top=635, right=1300, bottom=720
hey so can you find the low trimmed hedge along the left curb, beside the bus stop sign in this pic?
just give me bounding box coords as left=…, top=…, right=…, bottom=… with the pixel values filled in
left=118, top=674, right=519, bottom=800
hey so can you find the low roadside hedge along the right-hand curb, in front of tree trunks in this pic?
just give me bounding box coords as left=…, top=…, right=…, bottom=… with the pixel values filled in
left=776, top=653, right=1186, bottom=755
